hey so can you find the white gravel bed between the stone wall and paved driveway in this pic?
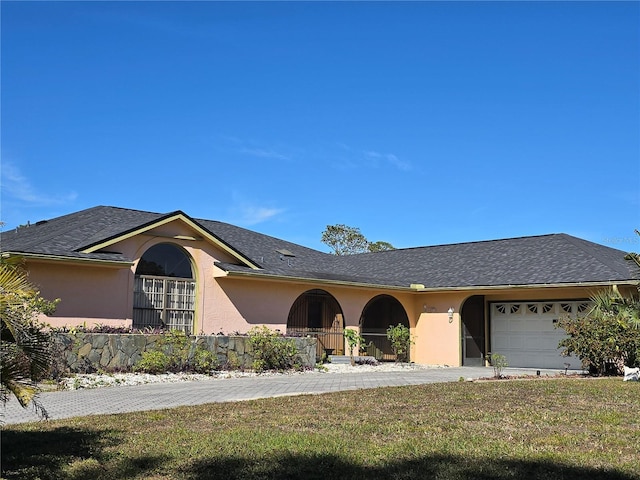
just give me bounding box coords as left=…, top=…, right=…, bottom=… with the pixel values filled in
left=59, top=363, right=444, bottom=390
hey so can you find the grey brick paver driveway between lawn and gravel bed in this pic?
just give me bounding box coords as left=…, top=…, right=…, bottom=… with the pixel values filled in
left=2, top=367, right=559, bottom=424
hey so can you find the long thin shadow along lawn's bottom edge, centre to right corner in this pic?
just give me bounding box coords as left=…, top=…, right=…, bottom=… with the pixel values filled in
left=182, top=455, right=638, bottom=480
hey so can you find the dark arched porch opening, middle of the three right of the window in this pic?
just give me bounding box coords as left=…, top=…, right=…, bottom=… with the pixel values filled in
left=360, top=295, right=410, bottom=361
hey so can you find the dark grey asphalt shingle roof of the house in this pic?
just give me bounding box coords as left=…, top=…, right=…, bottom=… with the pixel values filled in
left=0, top=206, right=640, bottom=288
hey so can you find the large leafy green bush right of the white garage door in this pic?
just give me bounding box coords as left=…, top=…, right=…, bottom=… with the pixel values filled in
left=557, top=288, right=640, bottom=375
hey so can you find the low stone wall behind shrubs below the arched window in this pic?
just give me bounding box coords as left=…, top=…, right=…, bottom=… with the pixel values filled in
left=53, top=333, right=317, bottom=373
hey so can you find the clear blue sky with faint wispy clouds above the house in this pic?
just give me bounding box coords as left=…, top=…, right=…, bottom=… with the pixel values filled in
left=0, top=1, right=640, bottom=251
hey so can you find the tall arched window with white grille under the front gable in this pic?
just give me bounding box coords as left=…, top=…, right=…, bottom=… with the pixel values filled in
left=133, top=243, right=196, bottom=335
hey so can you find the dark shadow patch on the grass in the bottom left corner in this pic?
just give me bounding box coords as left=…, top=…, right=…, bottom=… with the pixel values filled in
left=2, top=427, right=165, bottom=480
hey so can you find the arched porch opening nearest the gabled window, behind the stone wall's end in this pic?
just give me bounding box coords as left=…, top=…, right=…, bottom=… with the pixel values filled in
left=287, top=289, right=344, bottom=358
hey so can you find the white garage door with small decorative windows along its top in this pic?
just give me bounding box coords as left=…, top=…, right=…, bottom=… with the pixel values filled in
left=491, top=302, right=589, bottom=370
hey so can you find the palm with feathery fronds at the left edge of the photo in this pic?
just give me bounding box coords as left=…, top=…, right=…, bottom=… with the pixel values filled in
left=0, top=262, right=59, bottom=417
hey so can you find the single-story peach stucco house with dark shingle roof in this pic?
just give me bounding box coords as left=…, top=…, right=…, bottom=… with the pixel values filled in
left=0, top=206, right=640, bottom=369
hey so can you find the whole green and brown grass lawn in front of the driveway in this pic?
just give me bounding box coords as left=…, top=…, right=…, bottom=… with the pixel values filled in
left=2, top=378, right=640, bottom=480
